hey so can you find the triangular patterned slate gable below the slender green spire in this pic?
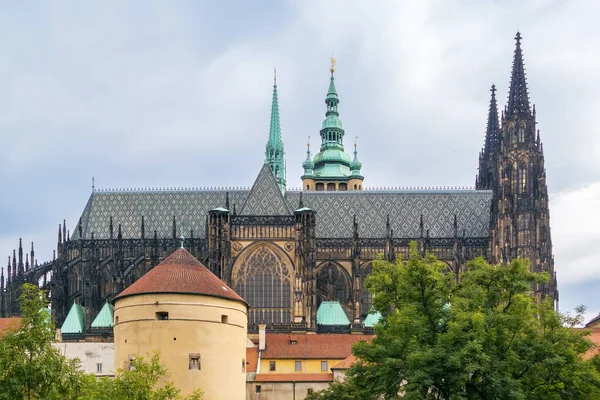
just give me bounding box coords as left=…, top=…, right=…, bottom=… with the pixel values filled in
left=240, top=164, right=292, bottom=216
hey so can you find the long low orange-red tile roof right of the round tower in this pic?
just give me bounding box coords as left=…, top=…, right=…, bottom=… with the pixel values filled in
left=261, top=333, right=373, bottom=360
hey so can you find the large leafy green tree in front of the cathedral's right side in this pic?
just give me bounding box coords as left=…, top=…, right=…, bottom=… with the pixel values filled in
left=312, top=243, right=600, bottom=400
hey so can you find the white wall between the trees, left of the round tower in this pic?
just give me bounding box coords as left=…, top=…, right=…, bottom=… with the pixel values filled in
left=53, top=342, right=115, bottom=376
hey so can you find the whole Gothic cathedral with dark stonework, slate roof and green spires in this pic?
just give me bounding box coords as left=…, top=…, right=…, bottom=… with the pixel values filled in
left=2, top=34, right=558, bottom=331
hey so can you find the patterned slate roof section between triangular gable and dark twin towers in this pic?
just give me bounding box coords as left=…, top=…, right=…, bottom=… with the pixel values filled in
left=287, top=190, right=492, bottom=238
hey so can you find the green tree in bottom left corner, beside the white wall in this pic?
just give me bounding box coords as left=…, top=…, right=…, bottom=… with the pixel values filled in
left=0, top=284, right=85, bottom=400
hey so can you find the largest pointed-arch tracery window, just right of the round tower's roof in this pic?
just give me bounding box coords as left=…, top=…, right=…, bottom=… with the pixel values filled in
left=234, top=246, right=292, bottom=324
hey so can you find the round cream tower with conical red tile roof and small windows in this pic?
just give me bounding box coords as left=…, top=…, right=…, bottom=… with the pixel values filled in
left=114, top=248, right=248, bottom=400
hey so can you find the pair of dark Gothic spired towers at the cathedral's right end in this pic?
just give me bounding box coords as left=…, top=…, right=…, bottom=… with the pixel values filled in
left=488, top=32, right=558, bottom=303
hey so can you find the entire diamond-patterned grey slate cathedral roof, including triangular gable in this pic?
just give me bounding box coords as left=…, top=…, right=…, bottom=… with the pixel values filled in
left=72, top=165, right=492, bottom=239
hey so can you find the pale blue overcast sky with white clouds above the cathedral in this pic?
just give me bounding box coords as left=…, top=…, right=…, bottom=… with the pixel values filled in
left=0, top=0, right=600, bottom=317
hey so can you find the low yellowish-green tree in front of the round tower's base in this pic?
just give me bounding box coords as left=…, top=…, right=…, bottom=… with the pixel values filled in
left=81, top=352, right=203, bottom=400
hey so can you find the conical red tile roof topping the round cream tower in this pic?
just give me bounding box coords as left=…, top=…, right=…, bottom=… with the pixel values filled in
left=115, top=249, right=247, bottom=304
